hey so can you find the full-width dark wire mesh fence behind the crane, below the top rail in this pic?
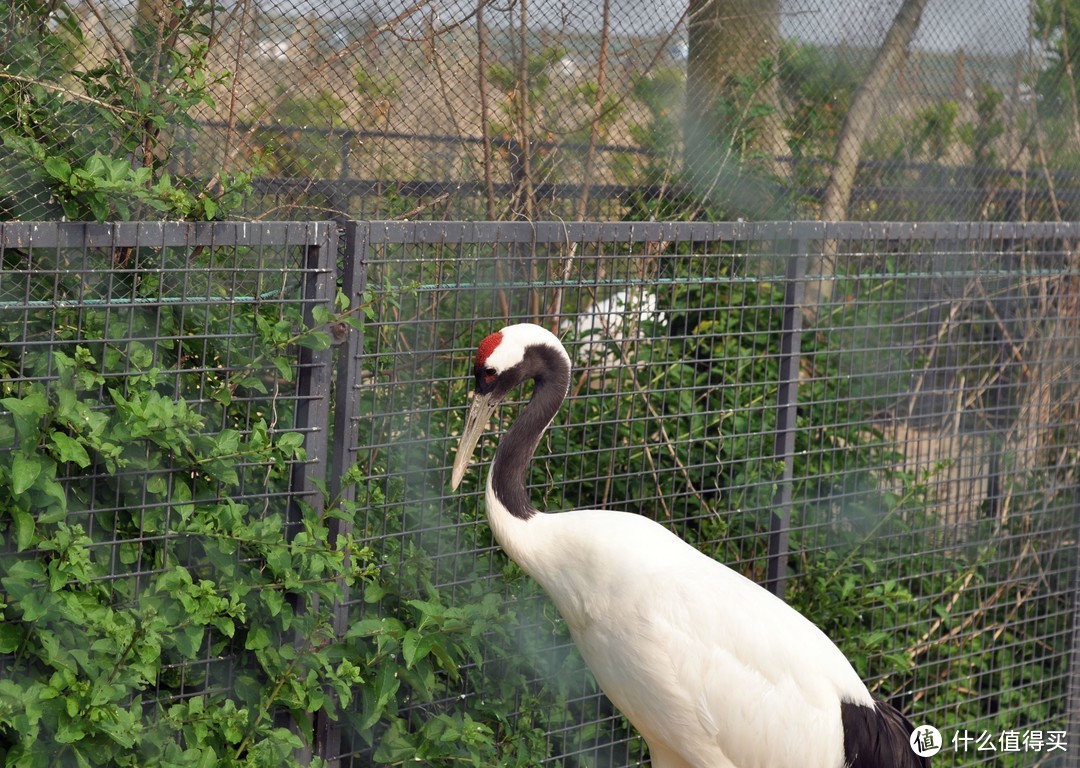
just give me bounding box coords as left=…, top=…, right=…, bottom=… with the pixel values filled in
left=0, top=221, right=1080, bottom=766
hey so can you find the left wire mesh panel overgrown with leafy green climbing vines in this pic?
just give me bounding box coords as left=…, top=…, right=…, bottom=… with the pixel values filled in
left=0, top=224, right=337, bottom=765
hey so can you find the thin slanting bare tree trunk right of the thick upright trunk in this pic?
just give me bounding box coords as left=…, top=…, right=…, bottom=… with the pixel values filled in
left=805, top=0, right=927, bottom=322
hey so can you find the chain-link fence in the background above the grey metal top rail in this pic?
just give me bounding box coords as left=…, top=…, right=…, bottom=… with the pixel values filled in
left=0, top=0, right=1080, bottom=220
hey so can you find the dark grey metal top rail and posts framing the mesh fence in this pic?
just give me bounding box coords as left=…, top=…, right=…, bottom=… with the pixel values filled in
left=0, top=221, right=1080, bottom=765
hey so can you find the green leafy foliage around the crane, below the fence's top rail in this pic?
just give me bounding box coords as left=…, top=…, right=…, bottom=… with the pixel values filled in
left=0, top=230, right=1076, bottom=766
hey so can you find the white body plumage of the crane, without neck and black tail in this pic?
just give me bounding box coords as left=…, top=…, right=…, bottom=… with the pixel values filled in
left=487, top=483, right=874, bottom=768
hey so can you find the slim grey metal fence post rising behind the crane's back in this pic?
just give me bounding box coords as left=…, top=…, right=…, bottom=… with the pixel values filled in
left=765, top=233, right=808, bottom=597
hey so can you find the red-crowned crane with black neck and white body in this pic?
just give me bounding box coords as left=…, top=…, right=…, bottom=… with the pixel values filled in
left=451, top=323, right=930, bottom=768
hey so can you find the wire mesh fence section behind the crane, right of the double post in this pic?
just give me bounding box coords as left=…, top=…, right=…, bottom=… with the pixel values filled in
left=332, top=223, right=1080, bottom=766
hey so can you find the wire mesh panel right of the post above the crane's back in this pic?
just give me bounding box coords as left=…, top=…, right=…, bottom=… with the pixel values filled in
left=793, top=225, right=1080, bottom=765
